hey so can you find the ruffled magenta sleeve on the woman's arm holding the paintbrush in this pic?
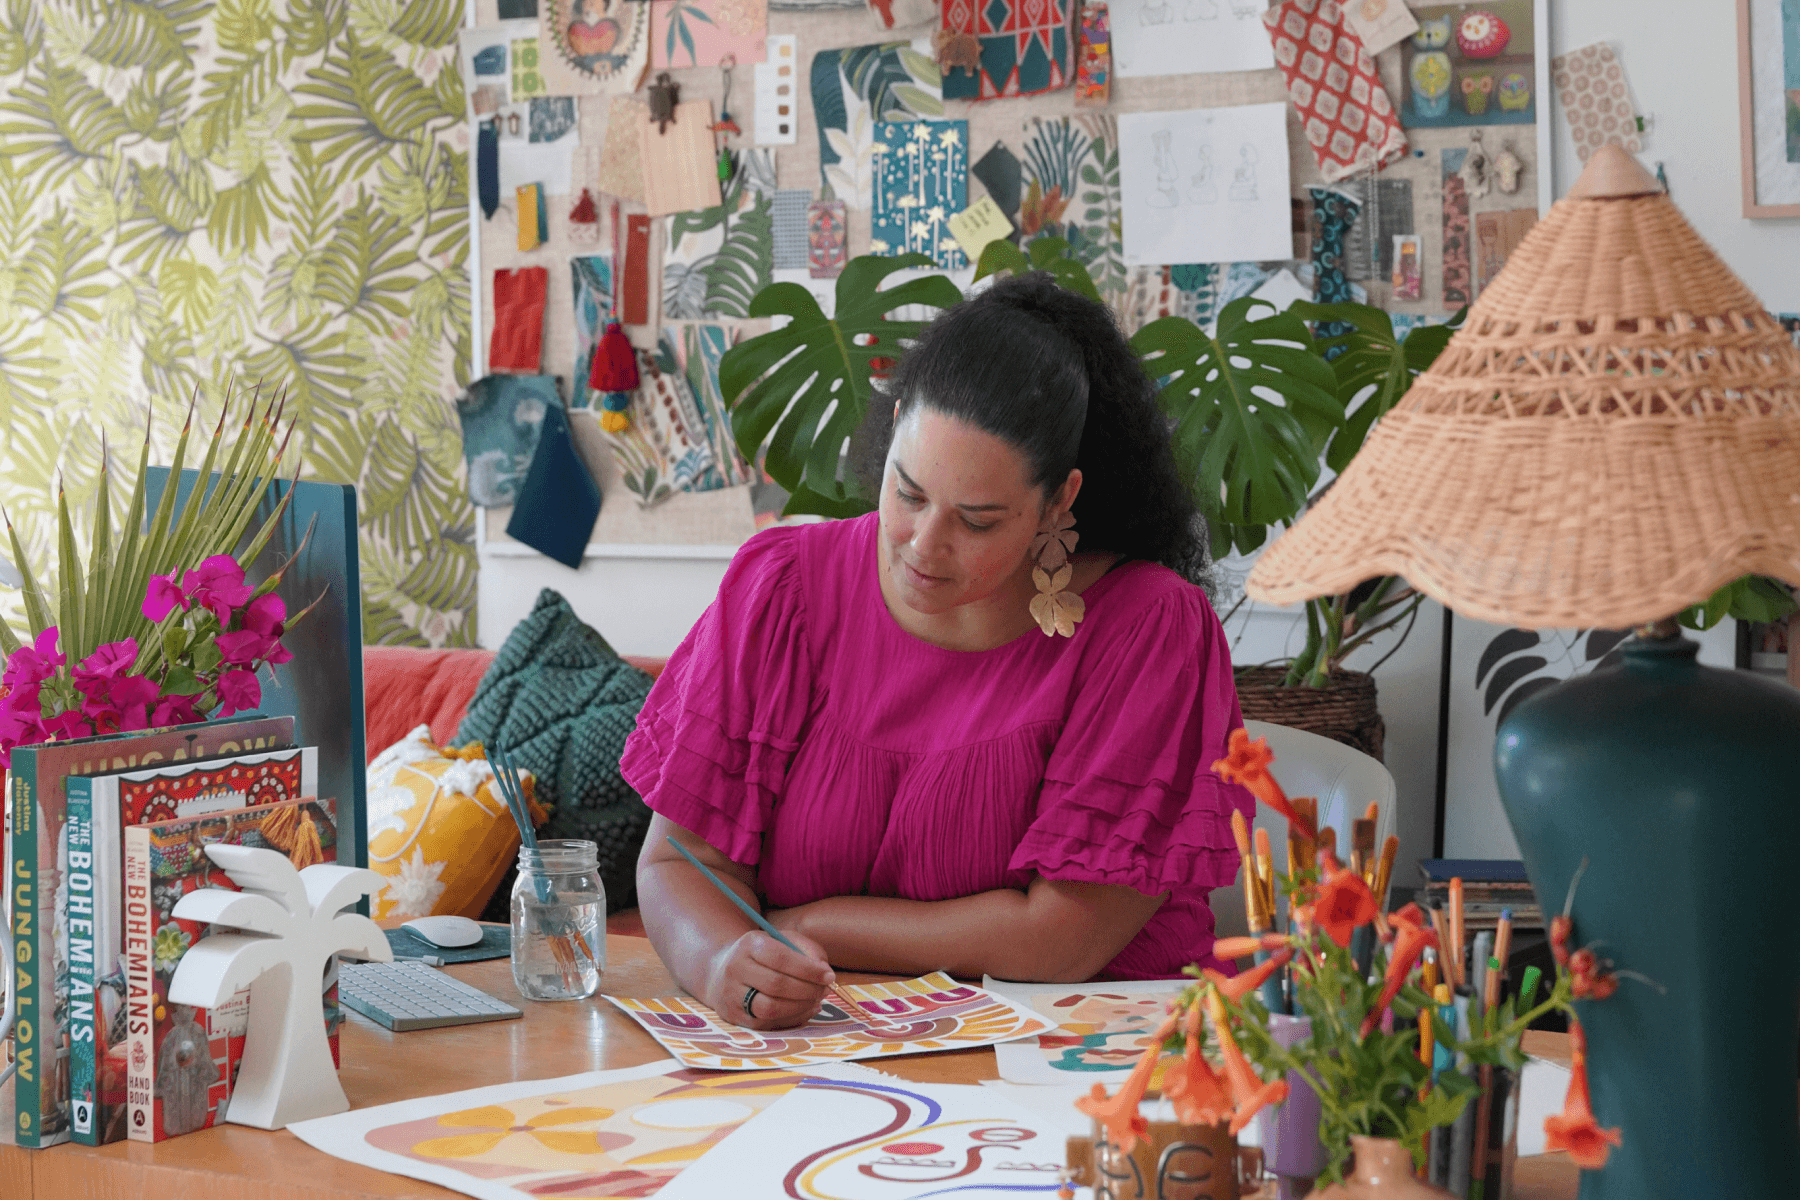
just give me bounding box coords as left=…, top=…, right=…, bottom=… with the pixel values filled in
left=619, top=529, right=815, bottom=864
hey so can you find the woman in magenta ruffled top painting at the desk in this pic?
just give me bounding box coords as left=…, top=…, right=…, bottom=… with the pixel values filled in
left=623, top=273, right=1251, bottom=1029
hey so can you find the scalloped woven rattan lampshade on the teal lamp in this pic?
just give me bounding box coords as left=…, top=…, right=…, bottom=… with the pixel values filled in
left=1247, top=146, right=1800, bottom=628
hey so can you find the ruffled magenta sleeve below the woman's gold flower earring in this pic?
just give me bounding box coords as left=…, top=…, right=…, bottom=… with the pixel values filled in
left=1010, top=588, right=1255, bottom=898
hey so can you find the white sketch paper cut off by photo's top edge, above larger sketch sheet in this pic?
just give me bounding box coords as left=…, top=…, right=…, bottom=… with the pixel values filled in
left=1109, top=0, right=1274, bottom=76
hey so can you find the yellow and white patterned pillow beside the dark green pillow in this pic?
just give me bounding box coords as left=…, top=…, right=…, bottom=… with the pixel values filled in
left=358, top=725, right=549, bottom=919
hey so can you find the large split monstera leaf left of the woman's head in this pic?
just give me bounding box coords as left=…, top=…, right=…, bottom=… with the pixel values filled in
left=718, top=254, right=963, bottom=516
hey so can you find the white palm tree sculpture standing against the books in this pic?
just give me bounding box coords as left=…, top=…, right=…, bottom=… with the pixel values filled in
left=169, top=846, right=394, bottom=1130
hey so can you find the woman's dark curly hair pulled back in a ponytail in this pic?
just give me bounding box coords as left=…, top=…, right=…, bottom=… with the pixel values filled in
left=851, top=272, right=1210, bottom=587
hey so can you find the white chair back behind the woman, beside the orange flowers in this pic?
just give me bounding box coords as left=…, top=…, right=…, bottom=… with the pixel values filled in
left=1211, top=721, right=1395, bottom=937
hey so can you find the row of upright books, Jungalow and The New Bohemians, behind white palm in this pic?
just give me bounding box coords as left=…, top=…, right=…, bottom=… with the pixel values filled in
left=0, top=714, right=338, bottom=1148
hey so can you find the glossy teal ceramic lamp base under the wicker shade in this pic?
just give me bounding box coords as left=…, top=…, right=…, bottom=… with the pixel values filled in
left=1494, top=637, right=1800, bottom=1200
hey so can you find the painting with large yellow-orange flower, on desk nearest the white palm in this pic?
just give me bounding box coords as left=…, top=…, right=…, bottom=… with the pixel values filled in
left=288, top=1060, right=801, bottom=1200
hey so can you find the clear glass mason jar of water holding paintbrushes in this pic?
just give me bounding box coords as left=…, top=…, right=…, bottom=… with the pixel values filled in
left=513, top=840, right=607, bottom=1000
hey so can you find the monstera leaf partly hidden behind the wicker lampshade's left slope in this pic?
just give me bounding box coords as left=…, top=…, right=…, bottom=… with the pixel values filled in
left=1289, top=300, right=1469, bottom=471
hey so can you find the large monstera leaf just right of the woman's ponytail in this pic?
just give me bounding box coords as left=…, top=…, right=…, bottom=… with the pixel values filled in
left=1130, top=297, right=1345, bottom=554
